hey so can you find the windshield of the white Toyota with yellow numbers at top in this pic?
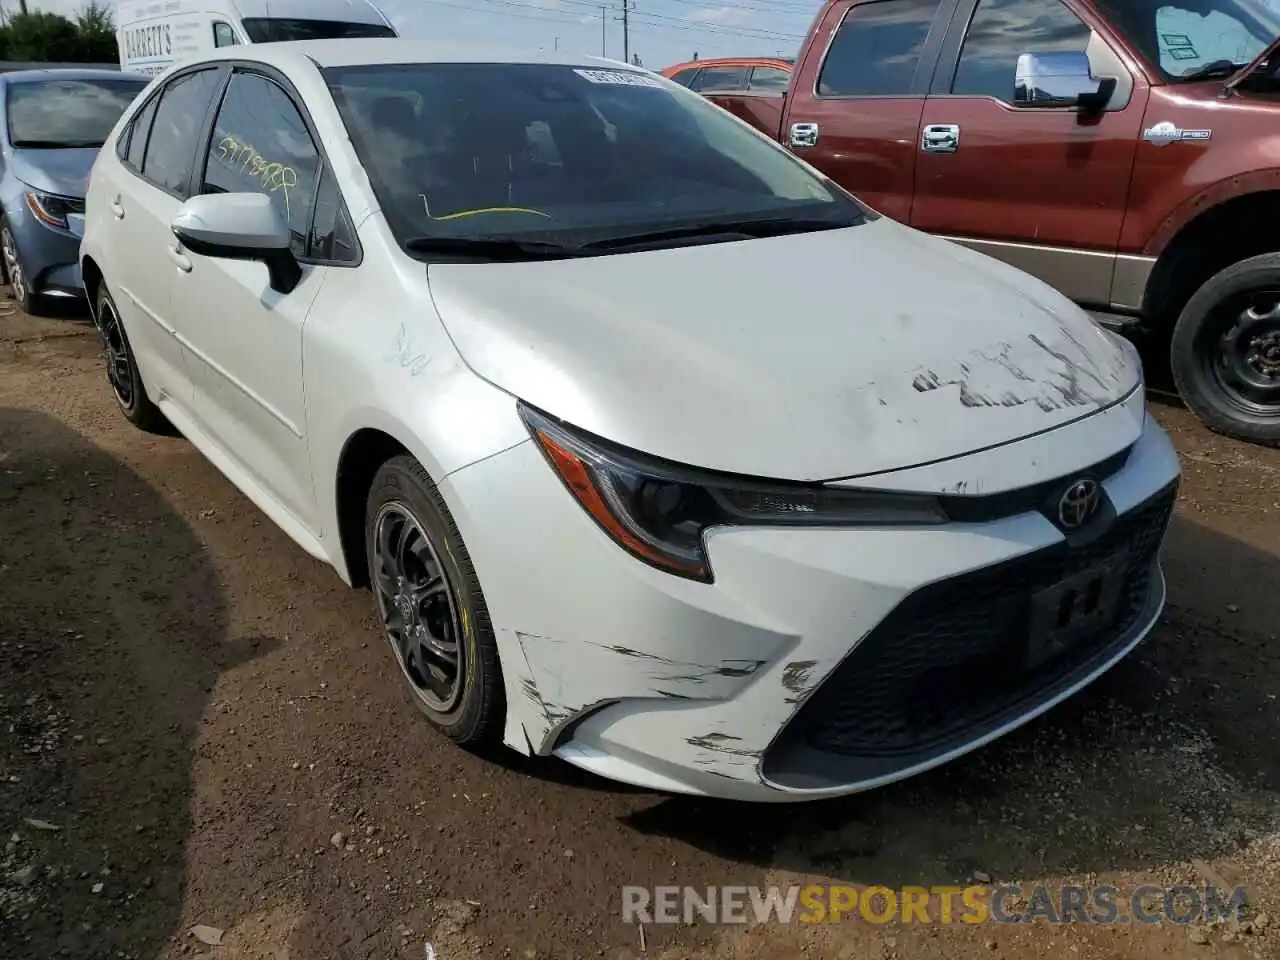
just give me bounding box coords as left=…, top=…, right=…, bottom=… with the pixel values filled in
left=325, top=63, right=865, bottom=252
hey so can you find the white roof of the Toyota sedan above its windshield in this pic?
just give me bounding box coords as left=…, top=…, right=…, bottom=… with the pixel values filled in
left=184, top=37, right=634, bottom=76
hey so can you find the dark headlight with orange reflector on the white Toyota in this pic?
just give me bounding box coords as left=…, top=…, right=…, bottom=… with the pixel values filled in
left=520, top=404, right=947, bottom=584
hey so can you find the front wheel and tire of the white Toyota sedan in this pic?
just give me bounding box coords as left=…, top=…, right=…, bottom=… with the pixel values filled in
left=365, top=456, right=504, bottom=745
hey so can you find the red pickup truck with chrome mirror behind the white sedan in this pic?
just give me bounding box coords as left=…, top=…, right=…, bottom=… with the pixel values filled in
left=710, top=0, right=1280, bottom=444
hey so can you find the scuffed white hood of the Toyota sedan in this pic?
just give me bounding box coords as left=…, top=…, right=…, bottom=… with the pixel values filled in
left=428, top=218, right=1142, bottom=480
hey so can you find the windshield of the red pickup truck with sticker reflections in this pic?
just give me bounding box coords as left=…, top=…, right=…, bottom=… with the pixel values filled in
left=1098, top=0, right=1280, bottom=81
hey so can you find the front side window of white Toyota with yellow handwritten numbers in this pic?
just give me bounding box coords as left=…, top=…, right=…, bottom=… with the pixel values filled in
left=201, top=73, right=320, bottom=256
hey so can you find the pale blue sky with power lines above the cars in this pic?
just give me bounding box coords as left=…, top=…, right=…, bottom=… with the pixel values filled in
left=12, top=0, right=822, bottom=68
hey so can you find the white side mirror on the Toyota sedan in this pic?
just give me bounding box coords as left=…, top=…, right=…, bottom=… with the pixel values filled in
left=170, top=193, right=302, bottom=293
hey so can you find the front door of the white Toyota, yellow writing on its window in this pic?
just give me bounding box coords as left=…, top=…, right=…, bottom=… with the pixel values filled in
left=174, top=69, right=325, bottom=534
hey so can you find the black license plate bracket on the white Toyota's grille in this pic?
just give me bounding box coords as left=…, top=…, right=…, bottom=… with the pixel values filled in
left=1027, top=550, right=1129, bottom=669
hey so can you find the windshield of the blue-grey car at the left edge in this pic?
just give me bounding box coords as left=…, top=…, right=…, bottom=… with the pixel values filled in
left=6, top=78, right=147, bottom=147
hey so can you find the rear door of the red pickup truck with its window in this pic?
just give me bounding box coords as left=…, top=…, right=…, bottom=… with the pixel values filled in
left=782, top=0, right=955, bottom=223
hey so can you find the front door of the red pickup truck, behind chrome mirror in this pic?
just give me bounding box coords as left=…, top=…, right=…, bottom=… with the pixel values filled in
left=910, top=0, right=1149, bottom=308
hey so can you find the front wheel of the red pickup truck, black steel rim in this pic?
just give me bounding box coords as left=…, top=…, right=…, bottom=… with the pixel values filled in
left=1170, top=253, right=1280, bottom=445
